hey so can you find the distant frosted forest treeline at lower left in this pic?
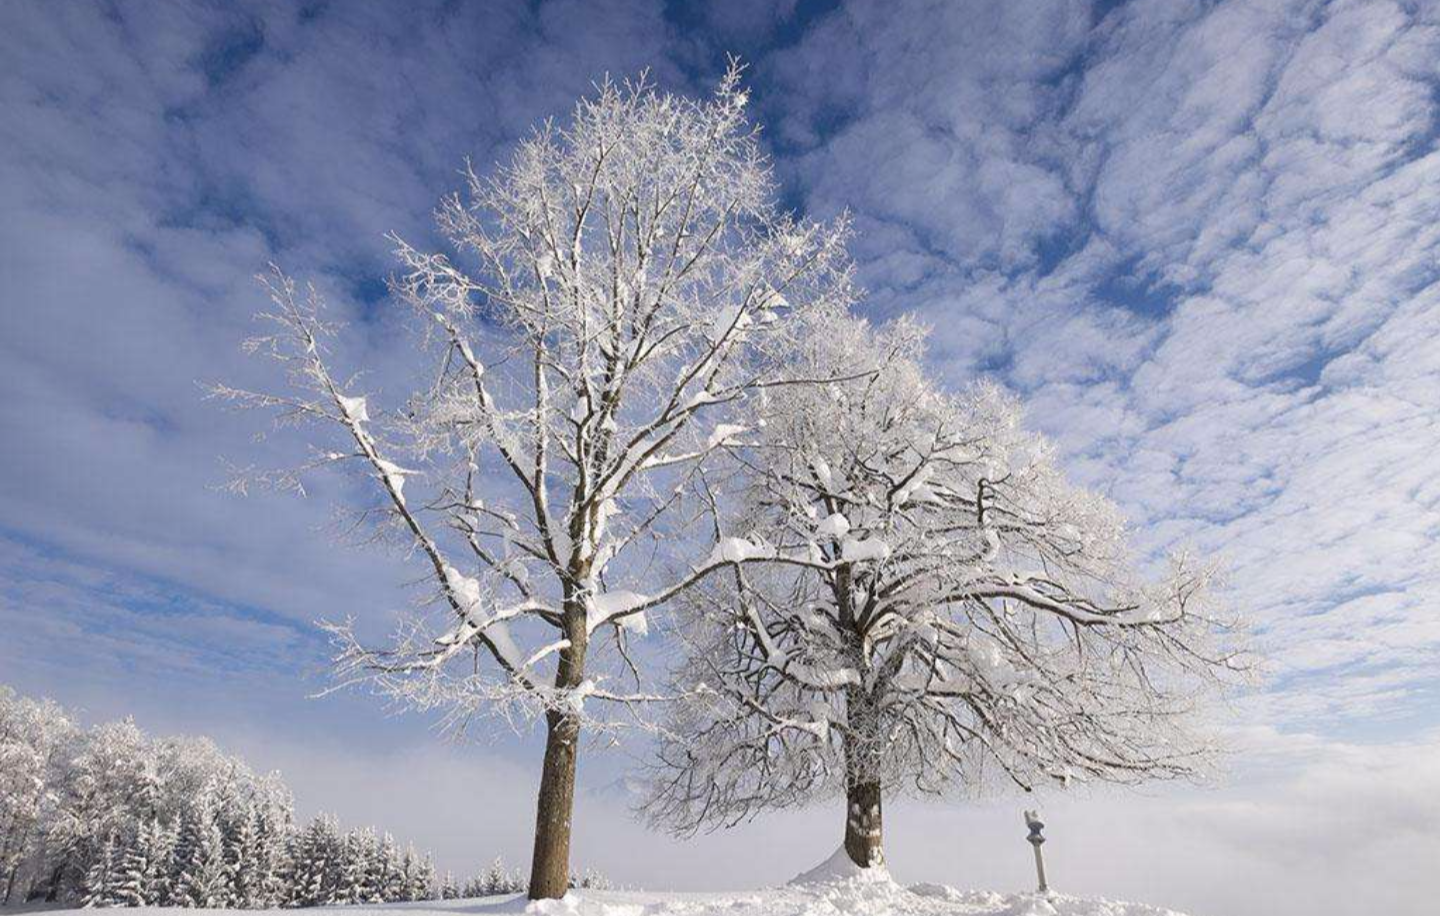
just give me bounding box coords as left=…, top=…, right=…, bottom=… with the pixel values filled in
left=0, top=684, right=609, bottom=909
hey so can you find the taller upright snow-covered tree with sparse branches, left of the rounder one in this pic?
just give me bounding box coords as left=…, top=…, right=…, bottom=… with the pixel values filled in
left=217, top=68, right=851, bottom=897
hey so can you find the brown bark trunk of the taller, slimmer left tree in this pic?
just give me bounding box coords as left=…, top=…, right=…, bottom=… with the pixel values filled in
left=530, top=587, right=589, bottom=900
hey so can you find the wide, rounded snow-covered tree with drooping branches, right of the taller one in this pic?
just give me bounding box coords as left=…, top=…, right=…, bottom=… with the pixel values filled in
left=649, top=320, right=1237, bottom=867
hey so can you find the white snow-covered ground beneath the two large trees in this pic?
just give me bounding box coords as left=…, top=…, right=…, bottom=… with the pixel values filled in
left=36, top=877, right=1182, bottom=916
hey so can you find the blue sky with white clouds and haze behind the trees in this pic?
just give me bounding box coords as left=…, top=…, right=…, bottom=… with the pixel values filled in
left=0, top=0, right=1440, bottom=913
